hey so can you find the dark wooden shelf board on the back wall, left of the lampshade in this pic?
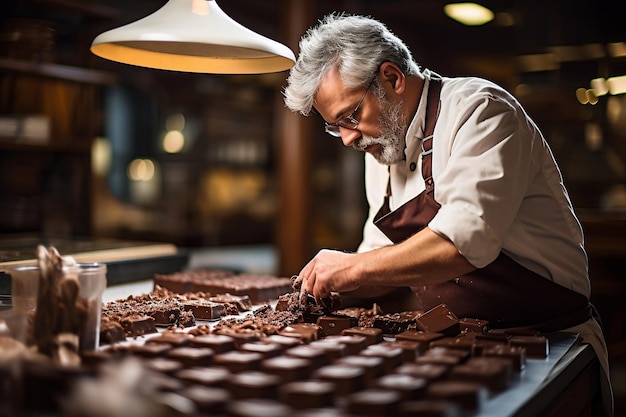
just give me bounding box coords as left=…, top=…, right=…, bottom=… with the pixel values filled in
left=0, top=58, right=117, bottom=85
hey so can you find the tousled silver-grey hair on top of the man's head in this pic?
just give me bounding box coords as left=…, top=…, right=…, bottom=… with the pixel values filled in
left=283, top=13, right=420, bottom=116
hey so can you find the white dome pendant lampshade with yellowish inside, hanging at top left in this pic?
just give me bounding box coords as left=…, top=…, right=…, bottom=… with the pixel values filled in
left=91, top=0, right=295, bottom=74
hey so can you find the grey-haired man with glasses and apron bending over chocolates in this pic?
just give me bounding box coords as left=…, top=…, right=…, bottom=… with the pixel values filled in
left=284, top=14, right=612, bottom=413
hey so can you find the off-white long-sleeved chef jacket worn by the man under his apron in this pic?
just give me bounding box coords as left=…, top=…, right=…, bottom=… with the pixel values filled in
left=358, top=70, right=608, bottom=414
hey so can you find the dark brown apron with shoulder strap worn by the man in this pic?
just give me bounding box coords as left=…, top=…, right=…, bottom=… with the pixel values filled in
left=374, top=79, right=594, bottom=331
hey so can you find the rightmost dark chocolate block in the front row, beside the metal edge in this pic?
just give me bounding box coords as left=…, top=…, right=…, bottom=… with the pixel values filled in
left=426, top=381, right=487, bottom=412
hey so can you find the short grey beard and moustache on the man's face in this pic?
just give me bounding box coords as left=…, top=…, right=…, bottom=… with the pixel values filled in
left=352, top=96, right=407, bottom=165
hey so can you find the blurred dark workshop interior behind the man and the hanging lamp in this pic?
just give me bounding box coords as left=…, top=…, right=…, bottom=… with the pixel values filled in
left=0, top=0, right=626, bottom=410
